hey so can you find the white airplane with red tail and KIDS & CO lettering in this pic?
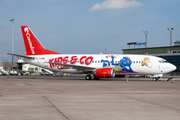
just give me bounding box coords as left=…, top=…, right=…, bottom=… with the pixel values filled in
left=7, top=26, right=176, bottom=80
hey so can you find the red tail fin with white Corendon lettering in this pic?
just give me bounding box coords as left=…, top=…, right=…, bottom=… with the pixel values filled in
left=21, top=26, right=60, bottom=55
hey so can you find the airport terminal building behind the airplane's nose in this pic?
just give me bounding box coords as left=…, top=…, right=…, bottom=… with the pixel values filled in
left=122, top=45, right=180, bottom=76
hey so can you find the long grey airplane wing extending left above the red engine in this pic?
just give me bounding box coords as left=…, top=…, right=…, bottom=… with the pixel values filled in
left=48, top=62, right=96, bottom=71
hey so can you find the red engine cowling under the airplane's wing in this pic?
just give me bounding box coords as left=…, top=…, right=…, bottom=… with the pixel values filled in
left=94, top=68, right=115, bottom=78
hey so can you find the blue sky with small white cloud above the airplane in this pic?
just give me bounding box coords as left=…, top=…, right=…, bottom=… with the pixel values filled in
left=0, top=0, right=180, bottom=61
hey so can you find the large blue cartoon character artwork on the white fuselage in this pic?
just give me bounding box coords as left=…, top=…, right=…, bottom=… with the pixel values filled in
left=101, top=56, right=134, bottom=73
